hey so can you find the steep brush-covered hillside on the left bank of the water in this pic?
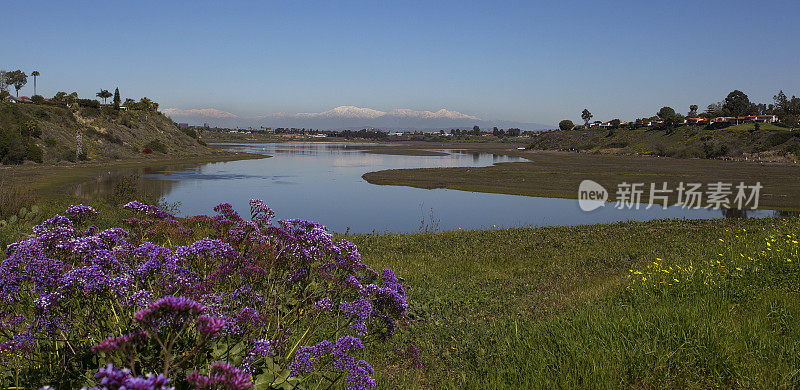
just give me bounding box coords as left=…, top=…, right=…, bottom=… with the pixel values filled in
left=0, top=103, right=213, bottom=164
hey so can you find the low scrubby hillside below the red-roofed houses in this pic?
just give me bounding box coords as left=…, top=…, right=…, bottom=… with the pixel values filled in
left=529, top=123, right=800, bottom=161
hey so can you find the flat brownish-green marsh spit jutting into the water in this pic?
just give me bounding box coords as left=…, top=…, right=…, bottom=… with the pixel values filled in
left=363, top=150, right=800, bottom=210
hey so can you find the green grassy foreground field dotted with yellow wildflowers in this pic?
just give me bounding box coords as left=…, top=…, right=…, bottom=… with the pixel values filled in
left=348, top=219, right=800, bottom=389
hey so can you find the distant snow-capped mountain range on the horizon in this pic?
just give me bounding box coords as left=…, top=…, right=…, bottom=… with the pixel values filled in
left=161, top=106, right=555, bottom=131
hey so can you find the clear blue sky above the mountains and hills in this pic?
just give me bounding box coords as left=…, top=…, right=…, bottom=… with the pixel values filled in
left=0, top=0, right=800, bottom=123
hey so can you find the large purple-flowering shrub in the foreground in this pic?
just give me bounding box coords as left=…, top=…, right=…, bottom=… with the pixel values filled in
left=0, top=200, right=407, bottom=389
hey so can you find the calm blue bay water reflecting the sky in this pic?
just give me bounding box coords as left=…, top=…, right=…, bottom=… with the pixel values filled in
left=70, top=143, right=774, bottom=233
